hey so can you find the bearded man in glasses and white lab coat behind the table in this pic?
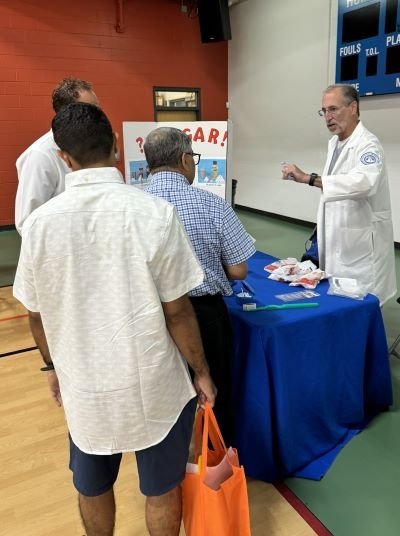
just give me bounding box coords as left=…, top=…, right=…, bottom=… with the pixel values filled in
left=282, top=84, right=396, bottom=305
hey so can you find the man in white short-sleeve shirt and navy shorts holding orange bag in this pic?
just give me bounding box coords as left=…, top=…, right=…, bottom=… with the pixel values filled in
left=14, top=103, right=215, bottom=535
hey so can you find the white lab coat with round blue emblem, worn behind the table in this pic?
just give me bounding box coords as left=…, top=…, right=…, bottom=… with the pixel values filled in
left=318, top=122, right=396, bottom=305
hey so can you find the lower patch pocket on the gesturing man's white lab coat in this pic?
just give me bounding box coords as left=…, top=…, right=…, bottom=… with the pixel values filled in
left=337, top=227, right=373, bottom=269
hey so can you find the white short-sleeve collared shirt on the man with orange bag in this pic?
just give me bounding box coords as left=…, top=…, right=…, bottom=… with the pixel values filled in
left=14, top=168, right=203, bottom=454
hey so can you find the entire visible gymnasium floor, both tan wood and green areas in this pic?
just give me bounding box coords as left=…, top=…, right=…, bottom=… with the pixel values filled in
left=0, top=210, right=400, bottom=536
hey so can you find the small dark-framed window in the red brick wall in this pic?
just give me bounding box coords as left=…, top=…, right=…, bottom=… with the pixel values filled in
left=153, top=87, right=201, bottom=121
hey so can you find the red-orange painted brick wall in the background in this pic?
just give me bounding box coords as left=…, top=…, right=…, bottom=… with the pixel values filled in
left=0, top=0, right=228, bottom=226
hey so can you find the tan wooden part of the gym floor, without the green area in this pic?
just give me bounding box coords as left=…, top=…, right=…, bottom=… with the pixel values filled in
left=0, top=287, right=316, bottom=536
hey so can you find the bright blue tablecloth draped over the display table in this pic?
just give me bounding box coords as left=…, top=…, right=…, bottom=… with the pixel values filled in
left=226, top=252, right=392, bottom=482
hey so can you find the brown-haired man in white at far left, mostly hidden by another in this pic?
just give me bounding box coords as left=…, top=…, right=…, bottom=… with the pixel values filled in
left=15, top=78, right=99, bottom=234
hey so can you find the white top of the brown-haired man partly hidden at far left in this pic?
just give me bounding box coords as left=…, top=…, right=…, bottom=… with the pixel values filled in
left=15, top=130, right=70, bottom=234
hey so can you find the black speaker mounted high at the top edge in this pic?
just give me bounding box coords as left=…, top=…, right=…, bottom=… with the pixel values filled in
left=197, top=0, right=232, bottom=43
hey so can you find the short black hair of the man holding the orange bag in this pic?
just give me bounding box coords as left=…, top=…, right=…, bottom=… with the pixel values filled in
left=51, top=102, right=114, bottom=167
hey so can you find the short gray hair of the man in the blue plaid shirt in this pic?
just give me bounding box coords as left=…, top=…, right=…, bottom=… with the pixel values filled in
left=143, top=127, right=192, bottom=172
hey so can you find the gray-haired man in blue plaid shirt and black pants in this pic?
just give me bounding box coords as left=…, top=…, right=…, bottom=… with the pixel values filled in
left=144, top=127, right=255, bottom=444
